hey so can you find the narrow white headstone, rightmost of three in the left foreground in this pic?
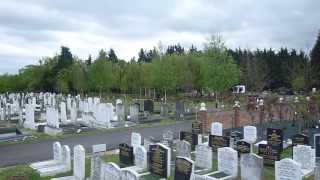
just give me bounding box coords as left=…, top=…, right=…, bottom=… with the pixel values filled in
left=73, top=145, right=86, bottom=180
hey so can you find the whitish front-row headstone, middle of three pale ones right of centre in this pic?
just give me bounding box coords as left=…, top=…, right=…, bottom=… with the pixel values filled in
left=218, top=147, right=238, bottom=178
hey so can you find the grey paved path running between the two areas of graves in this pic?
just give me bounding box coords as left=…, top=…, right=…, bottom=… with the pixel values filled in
left=0, top=122, right=191, bottom=167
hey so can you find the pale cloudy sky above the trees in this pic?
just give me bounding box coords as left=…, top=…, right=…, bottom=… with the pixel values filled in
left=0, top=0, right=320, bottom=74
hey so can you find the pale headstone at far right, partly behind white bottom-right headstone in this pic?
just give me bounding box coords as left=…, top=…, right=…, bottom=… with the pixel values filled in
left=293, top=145, right=316, bottom=172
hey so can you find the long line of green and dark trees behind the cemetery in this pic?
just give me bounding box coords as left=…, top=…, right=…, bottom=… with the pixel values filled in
left=0, top=32, right=320, bottom=93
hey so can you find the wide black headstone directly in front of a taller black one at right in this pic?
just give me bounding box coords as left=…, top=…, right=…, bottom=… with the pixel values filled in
left=258, top=144, right=280, bottom=166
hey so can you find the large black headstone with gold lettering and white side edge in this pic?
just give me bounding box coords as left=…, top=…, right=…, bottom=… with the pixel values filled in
left=149, top=143, right=171, bottom=178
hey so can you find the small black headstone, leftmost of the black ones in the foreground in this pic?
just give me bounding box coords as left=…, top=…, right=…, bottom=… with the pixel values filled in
left=119, top=143, right=134, bottom=167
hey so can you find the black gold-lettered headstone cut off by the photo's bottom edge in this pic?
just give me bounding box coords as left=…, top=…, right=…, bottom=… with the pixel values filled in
left=174, top=156, right=194, bottom=180
